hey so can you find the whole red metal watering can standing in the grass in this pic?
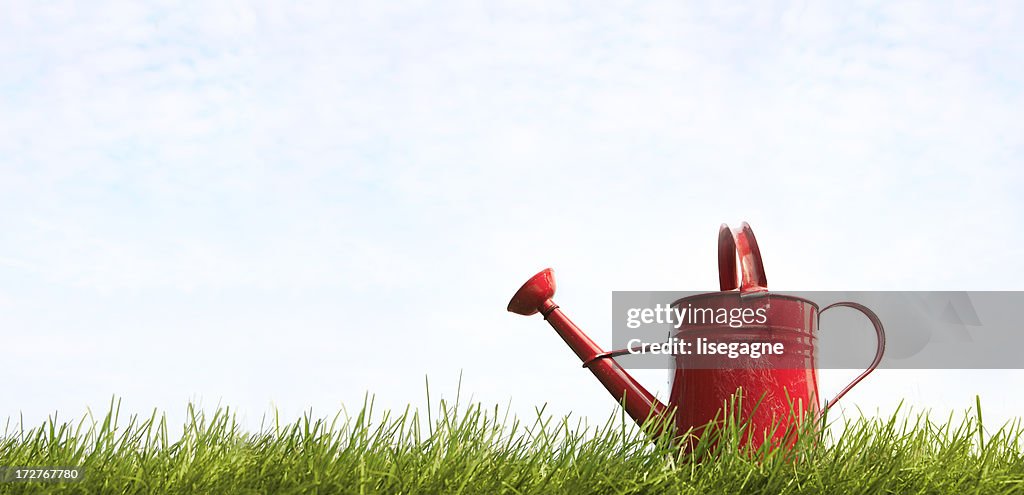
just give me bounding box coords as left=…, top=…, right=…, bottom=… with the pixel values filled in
left=508, top=222, right=885, bottom=448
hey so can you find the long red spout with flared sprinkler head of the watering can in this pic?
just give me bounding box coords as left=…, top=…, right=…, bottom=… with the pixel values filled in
left=508, top=269, right=669, bottom=435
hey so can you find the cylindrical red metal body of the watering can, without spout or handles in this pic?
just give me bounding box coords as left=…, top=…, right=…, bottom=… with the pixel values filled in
left=669, top=291, right=819, bottom=448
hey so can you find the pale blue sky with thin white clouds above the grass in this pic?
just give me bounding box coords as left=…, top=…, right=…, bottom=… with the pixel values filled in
left=0, top=1, right=1024, bottom=434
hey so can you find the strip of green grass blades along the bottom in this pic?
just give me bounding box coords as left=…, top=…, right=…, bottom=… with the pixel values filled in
left=0, top=393, right=1024, bottom=494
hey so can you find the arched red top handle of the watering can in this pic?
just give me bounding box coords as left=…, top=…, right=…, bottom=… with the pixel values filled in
left=718, top=221, right=768, bottom=294
